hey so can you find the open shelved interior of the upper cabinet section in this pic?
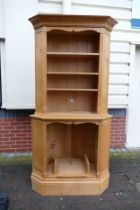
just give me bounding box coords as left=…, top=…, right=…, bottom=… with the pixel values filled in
left=47, top=30, right=99, bottom=112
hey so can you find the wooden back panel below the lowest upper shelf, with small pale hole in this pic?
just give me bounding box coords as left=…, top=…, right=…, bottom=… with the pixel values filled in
left=47, top=91, right=97, bottom=113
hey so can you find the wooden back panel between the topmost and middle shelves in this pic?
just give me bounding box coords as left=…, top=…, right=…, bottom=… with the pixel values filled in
left=47, top=56, right=98, bottom=72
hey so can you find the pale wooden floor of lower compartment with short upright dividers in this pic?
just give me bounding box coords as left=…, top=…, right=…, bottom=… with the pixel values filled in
left=48, top=155, right=96, bottom=177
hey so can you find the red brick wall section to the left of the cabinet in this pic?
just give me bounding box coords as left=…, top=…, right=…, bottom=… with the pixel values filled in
left=0, top=110, right=34, bottom=152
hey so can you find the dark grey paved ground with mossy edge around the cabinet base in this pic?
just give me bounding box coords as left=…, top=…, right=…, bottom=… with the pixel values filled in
left=0, top=150, right=140, bottom=210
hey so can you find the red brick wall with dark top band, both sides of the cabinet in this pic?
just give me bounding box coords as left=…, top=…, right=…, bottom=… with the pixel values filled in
left=0, top=110, right=126, bottom=152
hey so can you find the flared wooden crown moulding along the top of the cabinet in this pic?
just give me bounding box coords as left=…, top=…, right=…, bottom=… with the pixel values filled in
left=29, top=14, right=117, bottom=31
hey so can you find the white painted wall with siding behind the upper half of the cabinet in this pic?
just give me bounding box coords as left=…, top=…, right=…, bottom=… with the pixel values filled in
left=0, top=0, right=140, bottom=109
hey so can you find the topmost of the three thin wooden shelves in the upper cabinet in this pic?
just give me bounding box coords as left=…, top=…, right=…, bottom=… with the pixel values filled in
left=47, top=52, right=99, bottom=57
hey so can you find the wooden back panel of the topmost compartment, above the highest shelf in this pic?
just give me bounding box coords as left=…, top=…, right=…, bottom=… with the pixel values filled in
left=47, top=32, right=99, bottom=53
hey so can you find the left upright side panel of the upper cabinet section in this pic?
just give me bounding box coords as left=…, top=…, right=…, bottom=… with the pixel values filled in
left=35, top=29, right=47, bottom=113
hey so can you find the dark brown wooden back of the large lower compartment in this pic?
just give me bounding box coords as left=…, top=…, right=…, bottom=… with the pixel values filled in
left=47, top=123, right=98, bottom=166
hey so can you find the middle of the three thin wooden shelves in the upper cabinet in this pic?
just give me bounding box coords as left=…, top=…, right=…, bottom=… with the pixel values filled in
left=47, top=71, right=99, bottom=76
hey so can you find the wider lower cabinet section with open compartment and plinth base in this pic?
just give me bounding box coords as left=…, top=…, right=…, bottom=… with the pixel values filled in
left=32, top=116, right=110, bottom=195
